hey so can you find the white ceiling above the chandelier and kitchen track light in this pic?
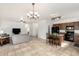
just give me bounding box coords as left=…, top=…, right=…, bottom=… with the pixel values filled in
left=0, top=3, right=79, bottom=19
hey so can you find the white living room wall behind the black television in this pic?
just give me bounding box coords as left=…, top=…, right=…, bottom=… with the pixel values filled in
left=0, top=20, right=27, bottom=35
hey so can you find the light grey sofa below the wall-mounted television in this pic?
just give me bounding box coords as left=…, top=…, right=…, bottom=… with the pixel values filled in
left=12, top=34, right=31, bottom=44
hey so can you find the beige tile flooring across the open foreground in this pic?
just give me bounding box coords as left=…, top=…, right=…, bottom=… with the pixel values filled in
left=0, top=38, right=79, bottom=56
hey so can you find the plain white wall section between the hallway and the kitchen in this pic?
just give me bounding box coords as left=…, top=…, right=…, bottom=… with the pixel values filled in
left=38, top=20, right=48, bottom=39
